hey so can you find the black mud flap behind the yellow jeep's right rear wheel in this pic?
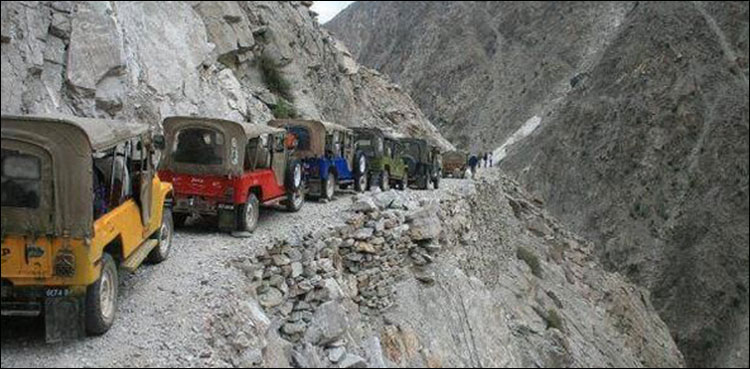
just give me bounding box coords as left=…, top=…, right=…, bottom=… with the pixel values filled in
left=44, top=295, right=86, bottom=343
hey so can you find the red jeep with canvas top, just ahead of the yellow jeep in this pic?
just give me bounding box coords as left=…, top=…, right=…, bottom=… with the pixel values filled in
left=159, top=117, right=305, bottom=232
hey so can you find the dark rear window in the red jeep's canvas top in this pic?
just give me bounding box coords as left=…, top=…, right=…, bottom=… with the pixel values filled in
left=172, top=128, right=226, bottom=165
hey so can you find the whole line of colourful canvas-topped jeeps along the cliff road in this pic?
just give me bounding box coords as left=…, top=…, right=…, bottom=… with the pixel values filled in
left=0, top=115, right=465, bottom=342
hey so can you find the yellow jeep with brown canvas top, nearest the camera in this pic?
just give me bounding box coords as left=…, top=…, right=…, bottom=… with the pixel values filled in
left=0, top=116, right=173, bottom=342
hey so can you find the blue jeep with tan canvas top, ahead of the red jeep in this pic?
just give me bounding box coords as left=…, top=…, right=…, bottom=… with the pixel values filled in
left=268, top=119, right=367, bottom=200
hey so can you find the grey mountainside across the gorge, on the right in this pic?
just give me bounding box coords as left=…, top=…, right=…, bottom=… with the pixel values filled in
left=326, top=2, right=750, bottom=366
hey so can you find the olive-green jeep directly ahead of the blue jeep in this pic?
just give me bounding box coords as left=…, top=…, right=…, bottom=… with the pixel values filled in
left=353, top=127, right=409, bottom=191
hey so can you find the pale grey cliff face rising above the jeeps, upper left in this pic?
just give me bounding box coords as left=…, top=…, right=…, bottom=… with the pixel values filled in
left=1, top=1, right=450, bottom=147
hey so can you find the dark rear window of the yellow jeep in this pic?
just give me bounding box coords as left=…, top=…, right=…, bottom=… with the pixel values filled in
left=2, top=149, right=42, bottom=209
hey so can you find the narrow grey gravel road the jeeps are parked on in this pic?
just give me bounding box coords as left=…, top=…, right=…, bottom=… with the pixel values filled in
left=0, top=180, right=470, bottom=368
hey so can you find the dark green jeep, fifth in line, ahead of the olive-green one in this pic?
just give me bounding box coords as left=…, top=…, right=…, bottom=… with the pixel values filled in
left=399, top=138, right=442, bottom=190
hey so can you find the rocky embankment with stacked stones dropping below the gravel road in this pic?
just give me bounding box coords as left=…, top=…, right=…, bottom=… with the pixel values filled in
left=216, top=173, right=684, bottom=368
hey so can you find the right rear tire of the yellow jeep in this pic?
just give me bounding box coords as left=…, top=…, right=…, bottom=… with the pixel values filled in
left=86, top=253, right=119, bottom=336
